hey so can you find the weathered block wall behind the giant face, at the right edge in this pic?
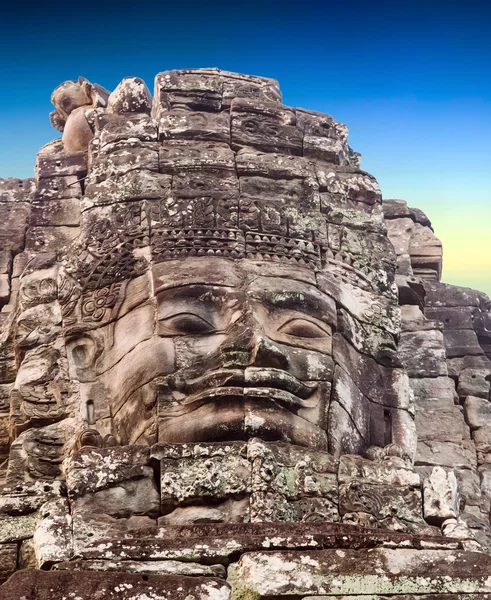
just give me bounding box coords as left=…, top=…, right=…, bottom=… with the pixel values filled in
left=384, top=200, right=491, bottom=548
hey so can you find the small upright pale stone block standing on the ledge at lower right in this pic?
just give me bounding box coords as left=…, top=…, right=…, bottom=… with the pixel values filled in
left=423, top=467, right=460, bottom=525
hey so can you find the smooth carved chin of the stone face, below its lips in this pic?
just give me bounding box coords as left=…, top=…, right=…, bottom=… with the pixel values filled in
left=159, top=397, right=327, bottom=450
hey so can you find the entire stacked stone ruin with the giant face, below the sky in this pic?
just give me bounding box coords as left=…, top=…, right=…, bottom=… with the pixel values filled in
left=0, top=69, right=491, bottom=600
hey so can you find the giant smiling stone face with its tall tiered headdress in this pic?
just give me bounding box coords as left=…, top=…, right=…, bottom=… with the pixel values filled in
left=22, top=70, right=415, bottom=459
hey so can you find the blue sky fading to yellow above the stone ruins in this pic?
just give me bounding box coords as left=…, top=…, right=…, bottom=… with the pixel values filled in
left=0, top=0, right=491, bottom=294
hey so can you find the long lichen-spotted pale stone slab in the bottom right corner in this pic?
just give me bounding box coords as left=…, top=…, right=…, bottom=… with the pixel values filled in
left=228, top=548, right=491, bottom=599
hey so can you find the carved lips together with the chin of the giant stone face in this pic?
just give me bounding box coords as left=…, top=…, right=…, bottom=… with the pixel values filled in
left=159, top=367, right=326, bottom=448
